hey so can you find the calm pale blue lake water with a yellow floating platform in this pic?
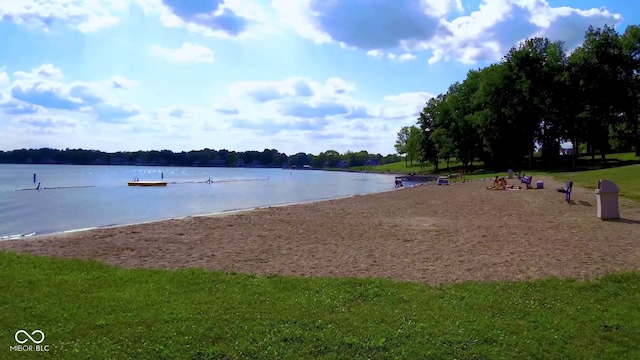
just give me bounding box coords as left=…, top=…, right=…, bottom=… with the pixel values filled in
left=0, top=164, right=394, bottom=239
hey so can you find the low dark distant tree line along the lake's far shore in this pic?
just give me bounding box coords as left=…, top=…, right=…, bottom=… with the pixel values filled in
left=0, top=148, right=402, bottom=168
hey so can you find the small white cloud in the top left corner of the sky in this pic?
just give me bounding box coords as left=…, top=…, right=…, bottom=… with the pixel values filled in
left=0, top=0, right=122, bottom=33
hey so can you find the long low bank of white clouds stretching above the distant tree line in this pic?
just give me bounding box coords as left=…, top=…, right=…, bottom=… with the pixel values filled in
left=0, top=67, right=438, bottom=153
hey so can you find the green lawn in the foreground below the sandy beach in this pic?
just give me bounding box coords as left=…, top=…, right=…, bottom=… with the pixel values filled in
left=0, top=252, right=640, bottom=359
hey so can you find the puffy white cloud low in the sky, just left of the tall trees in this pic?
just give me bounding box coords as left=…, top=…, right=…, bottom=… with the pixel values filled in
left=215, top=77, right=433, bottom=152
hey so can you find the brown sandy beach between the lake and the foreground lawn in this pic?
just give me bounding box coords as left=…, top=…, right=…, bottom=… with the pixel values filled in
left=0, top=178, right=640, bottom=284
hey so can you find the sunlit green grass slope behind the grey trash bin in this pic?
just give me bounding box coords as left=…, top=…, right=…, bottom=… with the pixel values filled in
left=549, top=165, right=640, bottom=201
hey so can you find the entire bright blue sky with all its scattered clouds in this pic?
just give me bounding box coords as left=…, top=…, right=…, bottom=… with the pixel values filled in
left=0, top=0, right=640, bottom=154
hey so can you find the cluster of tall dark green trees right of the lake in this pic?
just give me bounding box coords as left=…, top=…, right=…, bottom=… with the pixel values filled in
left=396, top=25, right=640, bottom=170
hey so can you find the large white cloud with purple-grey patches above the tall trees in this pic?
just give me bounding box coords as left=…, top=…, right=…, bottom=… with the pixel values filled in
left=272, top=0, right=622, bottom=64
